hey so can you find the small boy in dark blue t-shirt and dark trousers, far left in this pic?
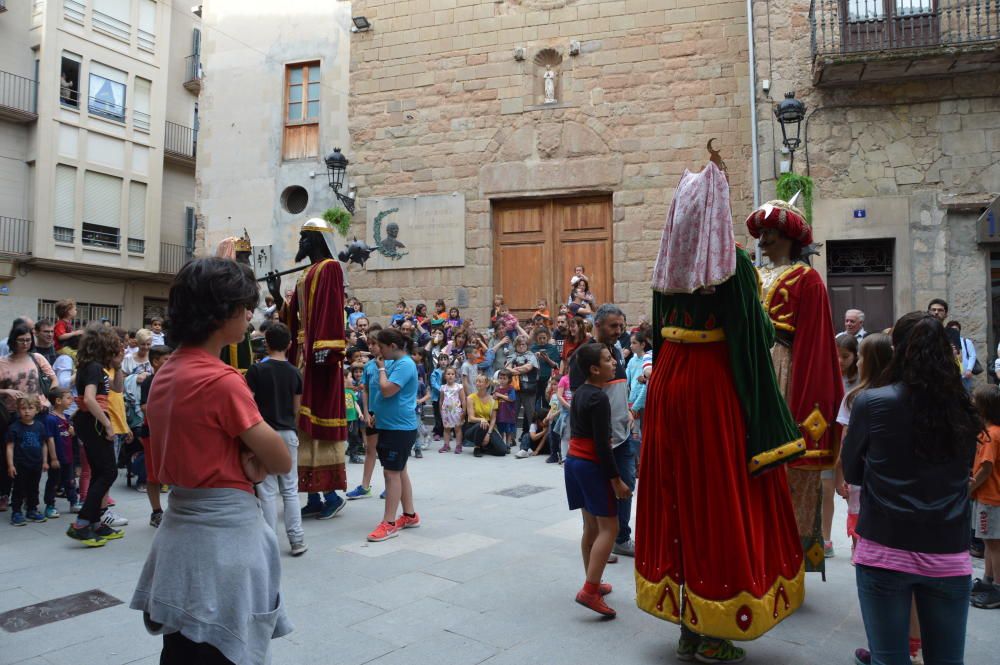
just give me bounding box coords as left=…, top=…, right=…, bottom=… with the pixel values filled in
left=7, top=395, right=59, bottom=526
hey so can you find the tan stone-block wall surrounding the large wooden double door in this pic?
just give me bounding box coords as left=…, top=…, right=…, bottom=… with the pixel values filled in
left=349, top=0, right=752, bottom=321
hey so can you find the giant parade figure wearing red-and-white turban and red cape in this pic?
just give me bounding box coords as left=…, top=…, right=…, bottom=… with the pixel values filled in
left=746, top=197, right=844, bottom=579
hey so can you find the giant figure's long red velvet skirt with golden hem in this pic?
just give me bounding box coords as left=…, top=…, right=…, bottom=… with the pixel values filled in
left=635, top=342, right=805, bottom=640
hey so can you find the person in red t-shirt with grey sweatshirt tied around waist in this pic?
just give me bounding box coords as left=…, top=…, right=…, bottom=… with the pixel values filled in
left=131, top=258, right=292, bottom=665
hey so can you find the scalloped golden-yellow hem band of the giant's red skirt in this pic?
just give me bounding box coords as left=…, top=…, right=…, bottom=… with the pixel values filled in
left=635, top=563, right=806, bottom=640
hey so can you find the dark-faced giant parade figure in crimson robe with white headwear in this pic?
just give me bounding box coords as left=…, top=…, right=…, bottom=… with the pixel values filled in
left=267, top=219, right=347, bottom=518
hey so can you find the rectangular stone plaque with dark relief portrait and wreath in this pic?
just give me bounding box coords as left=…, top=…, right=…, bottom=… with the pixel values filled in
left=366, top=192, right=465, bottom=270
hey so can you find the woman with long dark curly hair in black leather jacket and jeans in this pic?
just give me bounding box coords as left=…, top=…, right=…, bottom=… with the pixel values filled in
left=841, top=312, right=983, bottom=663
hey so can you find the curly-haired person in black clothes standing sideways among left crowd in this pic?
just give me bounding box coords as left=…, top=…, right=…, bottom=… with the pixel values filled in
left=66, top=324, right=125, bottom=547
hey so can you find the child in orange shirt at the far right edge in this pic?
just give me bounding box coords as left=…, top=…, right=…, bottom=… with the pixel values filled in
left=969, top=386, right=1000, bottom=609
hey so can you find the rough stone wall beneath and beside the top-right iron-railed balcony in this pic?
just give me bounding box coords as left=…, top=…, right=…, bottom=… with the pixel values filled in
left=754, top=0, right=1000, bottom=364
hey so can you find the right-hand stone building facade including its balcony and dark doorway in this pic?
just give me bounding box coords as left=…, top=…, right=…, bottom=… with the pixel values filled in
left=754, top=0, right=1000, bottom=358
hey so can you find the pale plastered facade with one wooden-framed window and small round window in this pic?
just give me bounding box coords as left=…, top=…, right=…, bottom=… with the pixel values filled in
left=197, top=0, right=351, bottom=276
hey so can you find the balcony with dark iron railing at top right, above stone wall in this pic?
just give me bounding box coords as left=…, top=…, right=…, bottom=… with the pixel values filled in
left=809, top=0, right=1000, bottom=86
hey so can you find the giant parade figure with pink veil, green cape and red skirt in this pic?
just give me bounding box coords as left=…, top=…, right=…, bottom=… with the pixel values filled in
left=635, top=163, right=805, bottom=663
